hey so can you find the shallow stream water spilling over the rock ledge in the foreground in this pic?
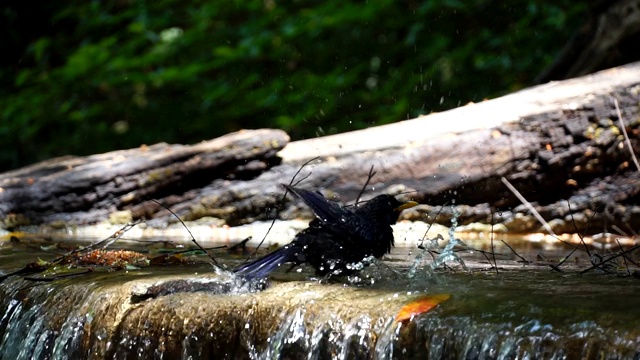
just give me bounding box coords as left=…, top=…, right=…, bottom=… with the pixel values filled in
left=0, top=235, right=640, bottom=360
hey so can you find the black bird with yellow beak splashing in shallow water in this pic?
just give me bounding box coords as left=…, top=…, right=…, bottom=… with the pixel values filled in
left=234, top=186, right=417, bottom=278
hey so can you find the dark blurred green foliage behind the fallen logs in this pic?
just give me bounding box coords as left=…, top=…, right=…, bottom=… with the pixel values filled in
left=0, top=0, right=588, bottom=171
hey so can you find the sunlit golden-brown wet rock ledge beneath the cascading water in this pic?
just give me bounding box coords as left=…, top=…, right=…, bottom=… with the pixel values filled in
left=0, top=274, right=436, bottom=358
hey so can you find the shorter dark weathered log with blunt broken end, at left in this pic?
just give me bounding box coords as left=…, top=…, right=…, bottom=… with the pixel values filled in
left=0, top=130, right=289, bottom=228
